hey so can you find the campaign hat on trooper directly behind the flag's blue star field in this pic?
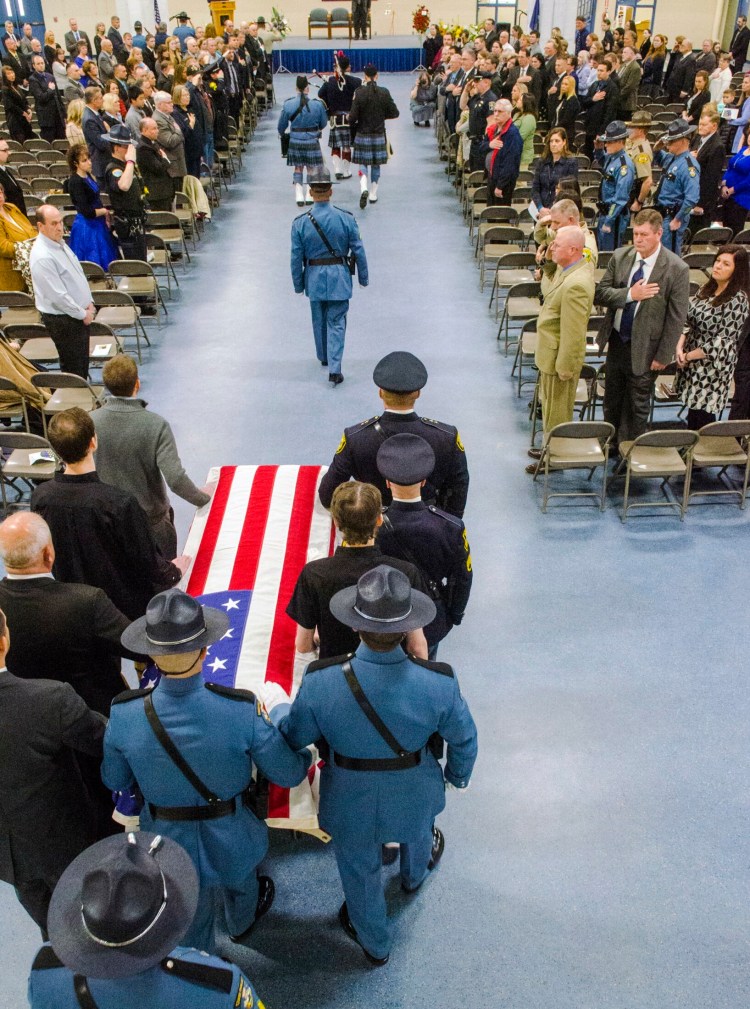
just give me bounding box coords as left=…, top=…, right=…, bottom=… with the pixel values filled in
left=120, top=588, right=229, bottom=656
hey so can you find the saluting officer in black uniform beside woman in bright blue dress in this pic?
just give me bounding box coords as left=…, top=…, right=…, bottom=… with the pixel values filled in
left=102, top=123, right=146, bottom=262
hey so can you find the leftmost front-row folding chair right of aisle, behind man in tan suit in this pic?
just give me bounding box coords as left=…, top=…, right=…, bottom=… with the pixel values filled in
left=534, top=421, right=615, bottom=512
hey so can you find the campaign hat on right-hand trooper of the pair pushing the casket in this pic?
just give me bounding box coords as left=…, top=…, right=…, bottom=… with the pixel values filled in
left=329, top=564, right=437, bottom=634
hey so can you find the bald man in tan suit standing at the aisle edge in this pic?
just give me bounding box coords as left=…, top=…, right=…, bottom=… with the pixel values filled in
left=526, top=227, right=595, bottom=474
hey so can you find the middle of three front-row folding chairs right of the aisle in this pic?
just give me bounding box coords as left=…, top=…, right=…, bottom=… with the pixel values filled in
left=613, top=430, right=698, bottom=522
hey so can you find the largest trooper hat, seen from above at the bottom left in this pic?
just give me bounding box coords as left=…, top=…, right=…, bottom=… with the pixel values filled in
left=47, top=830, right=198, bottom=979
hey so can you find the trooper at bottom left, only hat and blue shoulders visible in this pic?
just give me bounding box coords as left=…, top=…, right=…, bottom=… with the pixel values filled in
left=28, top=831, right=262, bottom=1009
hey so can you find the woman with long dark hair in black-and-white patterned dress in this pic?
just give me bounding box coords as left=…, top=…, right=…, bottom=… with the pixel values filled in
left=676, top=245, right=750, bottom=431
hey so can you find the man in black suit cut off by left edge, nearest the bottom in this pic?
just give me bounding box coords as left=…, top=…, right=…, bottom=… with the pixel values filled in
left=0, top=611, right=107, bottom=939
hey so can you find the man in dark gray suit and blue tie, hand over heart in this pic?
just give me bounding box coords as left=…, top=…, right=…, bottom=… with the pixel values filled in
left=595, top=210, right=690, bottom=443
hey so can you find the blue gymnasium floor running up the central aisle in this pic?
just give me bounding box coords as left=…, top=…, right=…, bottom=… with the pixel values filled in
left=0, top=76, right=750, bottom=1009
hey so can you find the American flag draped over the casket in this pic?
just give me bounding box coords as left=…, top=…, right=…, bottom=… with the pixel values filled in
left=182, top=466, right=334, bottom=830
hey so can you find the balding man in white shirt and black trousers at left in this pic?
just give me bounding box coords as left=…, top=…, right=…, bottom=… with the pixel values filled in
left=29, top=204, right=96, bottom=378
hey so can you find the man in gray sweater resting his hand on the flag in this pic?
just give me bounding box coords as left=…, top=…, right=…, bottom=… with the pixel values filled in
left=92, top=354, right=211, bottom=558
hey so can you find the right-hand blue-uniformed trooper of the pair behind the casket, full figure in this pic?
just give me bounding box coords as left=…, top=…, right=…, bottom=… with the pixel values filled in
left=274, top=564, right=476, bottom=967
